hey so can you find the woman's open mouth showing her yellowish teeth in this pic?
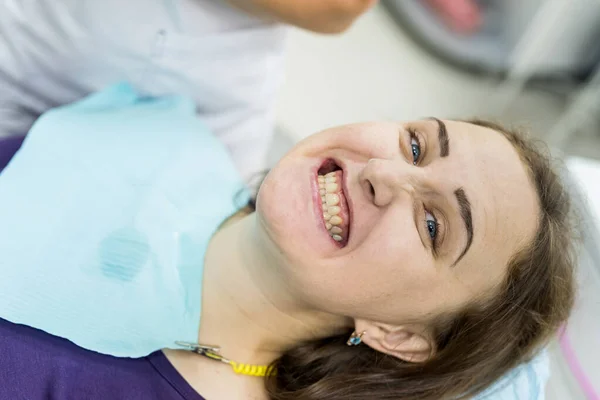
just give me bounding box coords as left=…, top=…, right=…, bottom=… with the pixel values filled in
left=317, top=159, right=350, bottom=247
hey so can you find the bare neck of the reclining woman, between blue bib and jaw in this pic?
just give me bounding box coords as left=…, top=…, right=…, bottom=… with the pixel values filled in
left=198, top=213, right=349, bottom=364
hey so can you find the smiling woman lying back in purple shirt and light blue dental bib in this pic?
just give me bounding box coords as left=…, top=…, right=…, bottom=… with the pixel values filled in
left=0, top=85, right=574, bottom=400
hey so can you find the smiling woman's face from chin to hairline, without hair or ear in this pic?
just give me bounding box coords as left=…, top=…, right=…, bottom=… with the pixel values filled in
left=257, top=119, right=539, bottom=324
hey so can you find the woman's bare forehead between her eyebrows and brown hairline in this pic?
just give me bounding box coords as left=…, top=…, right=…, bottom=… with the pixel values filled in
left=445, top=121, right=539, bottom=286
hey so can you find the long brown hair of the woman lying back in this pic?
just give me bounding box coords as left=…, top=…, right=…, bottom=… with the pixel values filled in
left=258, top=120, right=575, bottom=400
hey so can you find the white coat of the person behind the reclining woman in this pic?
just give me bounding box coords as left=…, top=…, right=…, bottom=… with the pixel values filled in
left=0, top=0, right=285, bottom=179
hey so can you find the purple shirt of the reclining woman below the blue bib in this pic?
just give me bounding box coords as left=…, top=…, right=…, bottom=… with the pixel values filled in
left=0, top=319, right=204, bottom=400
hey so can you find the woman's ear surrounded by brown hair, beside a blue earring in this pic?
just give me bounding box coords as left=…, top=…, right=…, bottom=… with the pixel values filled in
left=357, top=321, right=435, bottom=363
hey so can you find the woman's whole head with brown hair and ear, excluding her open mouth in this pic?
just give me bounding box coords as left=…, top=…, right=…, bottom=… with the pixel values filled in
left=257, top=119, right=574, bottom=400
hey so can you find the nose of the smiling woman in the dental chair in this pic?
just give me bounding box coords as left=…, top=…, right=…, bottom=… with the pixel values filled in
left=360, top=158, right=419, bottom=207
